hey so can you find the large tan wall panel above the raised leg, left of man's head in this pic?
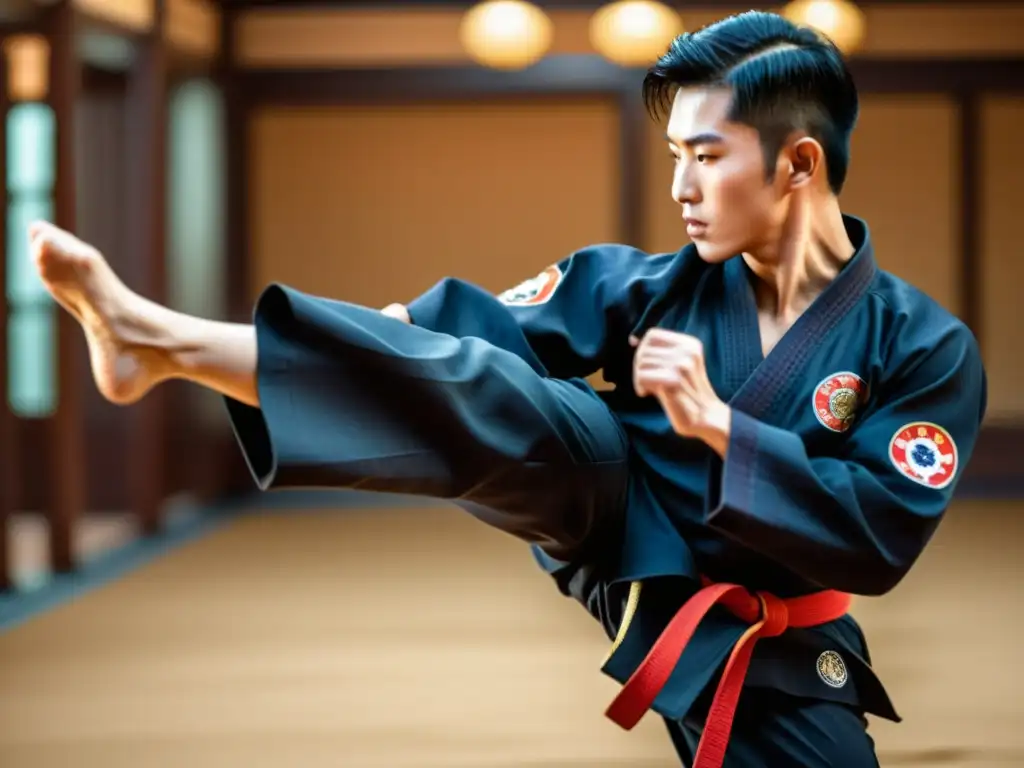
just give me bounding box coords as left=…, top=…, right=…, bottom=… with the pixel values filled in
left=250, top=97, right=618, bottom=313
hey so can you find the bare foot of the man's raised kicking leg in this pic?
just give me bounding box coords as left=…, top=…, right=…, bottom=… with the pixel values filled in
left=29, top=222, right=166, bottom=404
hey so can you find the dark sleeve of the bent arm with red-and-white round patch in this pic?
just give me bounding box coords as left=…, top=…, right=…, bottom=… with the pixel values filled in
left=707, top=329, right=986, bottom=595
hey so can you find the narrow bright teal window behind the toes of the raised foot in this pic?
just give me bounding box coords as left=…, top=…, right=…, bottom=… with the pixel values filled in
left=6, top=102, right=56, bottom=418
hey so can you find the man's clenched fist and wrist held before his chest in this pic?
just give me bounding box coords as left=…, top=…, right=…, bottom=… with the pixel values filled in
left=630, top=328, right=731, bottom=458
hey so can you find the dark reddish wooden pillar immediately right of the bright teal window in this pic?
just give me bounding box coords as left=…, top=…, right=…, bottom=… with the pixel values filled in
left=46, top=0, right=83, bottom=572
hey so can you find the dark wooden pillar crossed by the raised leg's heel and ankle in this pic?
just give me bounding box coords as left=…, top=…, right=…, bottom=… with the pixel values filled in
left=124, top=0, right=167, bottom=534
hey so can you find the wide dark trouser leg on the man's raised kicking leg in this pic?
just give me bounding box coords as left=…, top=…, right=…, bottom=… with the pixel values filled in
left=227, top=286, right=628, bottom=560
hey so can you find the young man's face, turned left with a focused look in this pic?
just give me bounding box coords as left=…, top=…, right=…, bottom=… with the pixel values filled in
left=667, top=88, right=785, bottom=263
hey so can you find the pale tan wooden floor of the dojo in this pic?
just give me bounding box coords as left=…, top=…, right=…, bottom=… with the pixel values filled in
left=0, top=503, right=1024, bottom=768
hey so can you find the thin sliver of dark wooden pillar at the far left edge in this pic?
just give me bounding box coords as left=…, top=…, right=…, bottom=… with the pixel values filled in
left=0, top=41, right=17, bottom=591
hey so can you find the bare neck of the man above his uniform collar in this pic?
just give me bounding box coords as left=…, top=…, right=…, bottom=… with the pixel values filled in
left=743, top=197, right=855, bottom=321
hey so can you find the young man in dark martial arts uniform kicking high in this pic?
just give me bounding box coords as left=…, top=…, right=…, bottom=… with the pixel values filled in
left=32, top=12, right=986, bottom=768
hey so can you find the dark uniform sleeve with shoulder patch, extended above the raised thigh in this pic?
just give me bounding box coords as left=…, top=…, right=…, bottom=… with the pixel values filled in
left=407, top=245, right=646, bottom=379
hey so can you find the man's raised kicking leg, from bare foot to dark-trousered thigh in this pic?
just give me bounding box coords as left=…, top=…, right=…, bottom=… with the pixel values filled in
left=32, top=225, right=627, bottom=560
